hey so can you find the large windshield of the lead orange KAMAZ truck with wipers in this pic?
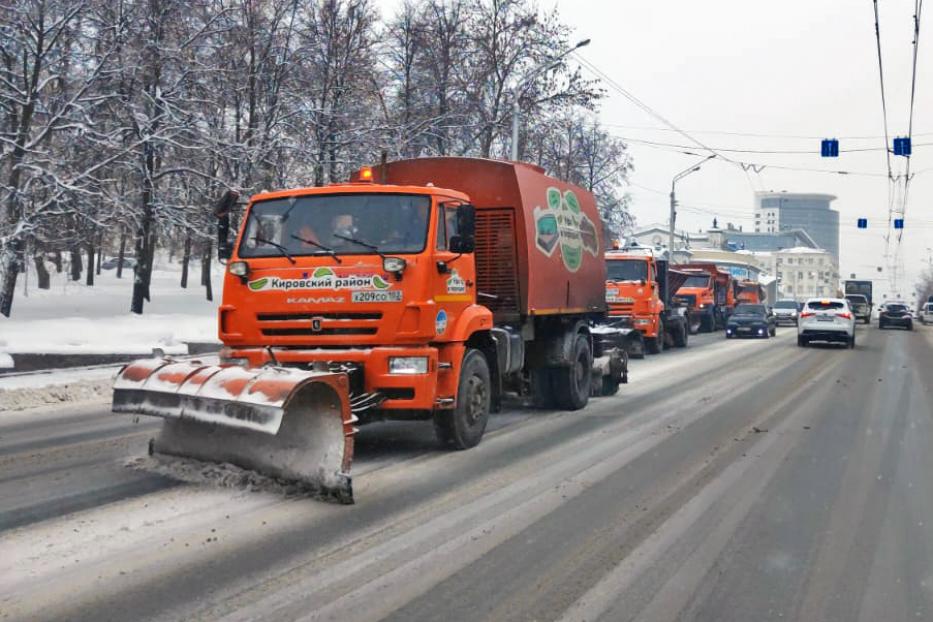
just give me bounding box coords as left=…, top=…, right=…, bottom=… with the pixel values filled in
left=239, top=193, right=431, bottom=257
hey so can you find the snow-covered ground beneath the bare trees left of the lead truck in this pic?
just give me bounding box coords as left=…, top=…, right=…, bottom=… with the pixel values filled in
left=0, top=258, right=222, bottom=358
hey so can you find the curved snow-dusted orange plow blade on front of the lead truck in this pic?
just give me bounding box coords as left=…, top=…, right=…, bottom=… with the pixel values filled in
left=113, top=359, right=356, bottom=503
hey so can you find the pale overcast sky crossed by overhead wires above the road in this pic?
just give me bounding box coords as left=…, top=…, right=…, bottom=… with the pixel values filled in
left=374, top=0, right=933, bottom=295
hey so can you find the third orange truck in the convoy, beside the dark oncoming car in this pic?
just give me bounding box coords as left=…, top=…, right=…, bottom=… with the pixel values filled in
left=675, top=263, right=735, bottom=333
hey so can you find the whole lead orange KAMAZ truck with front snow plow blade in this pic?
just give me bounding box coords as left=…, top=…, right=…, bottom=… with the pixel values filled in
left=113, top=158, right=632, bottom=503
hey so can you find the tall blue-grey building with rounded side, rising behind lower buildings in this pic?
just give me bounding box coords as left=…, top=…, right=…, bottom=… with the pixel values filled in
left=755, top=192, right=839, bottom=263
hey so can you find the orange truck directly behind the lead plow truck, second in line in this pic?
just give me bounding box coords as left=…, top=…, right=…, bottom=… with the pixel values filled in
left=606, top=243, right=690, bottom=356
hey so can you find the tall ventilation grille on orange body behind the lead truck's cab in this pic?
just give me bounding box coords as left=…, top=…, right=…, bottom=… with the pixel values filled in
left=475, top=208, right=519, bottom=316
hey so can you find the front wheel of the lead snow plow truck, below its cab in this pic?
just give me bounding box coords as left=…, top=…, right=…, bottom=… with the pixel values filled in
left=434, top=349, right=492, bottom=449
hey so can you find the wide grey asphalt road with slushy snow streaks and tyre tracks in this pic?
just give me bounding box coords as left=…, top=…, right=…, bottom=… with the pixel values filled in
left=0, top=326, right=933, bottom=622
